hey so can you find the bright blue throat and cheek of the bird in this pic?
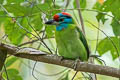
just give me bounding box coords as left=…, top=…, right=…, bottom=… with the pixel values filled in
left=56, top=19, right=72, bottom=31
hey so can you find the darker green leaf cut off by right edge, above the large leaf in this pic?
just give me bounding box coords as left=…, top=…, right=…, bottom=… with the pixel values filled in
left=111, top=19, right=120, bottom=36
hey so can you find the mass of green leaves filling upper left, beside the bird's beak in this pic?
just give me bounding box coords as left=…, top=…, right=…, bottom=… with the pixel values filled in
left=0, top=0, right=60, bottom=45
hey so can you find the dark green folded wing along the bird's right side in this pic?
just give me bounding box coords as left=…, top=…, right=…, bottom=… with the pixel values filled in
left=76, top=27, right=90, bottom=58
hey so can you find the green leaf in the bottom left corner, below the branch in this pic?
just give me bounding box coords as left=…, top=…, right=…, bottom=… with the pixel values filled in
left=2, top=68, right=23, bottom=80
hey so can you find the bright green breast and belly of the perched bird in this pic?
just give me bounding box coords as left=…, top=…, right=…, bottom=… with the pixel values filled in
left=55, top=30, right=87, bottom=61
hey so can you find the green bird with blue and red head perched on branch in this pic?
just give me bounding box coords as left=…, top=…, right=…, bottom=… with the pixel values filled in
left=45, top=12, right=89, bottom=61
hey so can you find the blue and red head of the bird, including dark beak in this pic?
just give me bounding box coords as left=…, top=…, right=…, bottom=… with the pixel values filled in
left=45, top=12, right=73, bottom=31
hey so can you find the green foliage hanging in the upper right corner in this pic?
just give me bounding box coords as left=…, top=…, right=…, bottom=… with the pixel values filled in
left=94, top=0, right=120, bottom=36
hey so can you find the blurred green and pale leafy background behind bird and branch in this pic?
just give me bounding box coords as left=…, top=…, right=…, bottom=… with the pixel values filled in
left=0, top=0, right=120, bottom=80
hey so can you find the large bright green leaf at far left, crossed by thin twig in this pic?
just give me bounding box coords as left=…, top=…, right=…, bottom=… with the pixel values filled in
left=4, top=18, right=31, bottom=45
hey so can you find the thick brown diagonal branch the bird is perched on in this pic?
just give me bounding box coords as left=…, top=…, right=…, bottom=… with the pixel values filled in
left=0, top=43, right=120, bottom=78
